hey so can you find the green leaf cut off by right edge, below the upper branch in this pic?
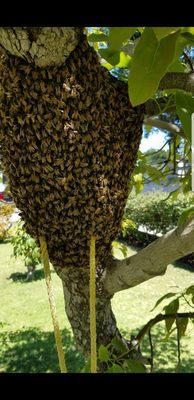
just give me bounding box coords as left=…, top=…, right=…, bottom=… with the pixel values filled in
left=175, top=90, right=194, bottom=143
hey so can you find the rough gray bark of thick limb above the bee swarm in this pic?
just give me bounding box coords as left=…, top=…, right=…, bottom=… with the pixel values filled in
left=0, top=27, right=81, bottom=67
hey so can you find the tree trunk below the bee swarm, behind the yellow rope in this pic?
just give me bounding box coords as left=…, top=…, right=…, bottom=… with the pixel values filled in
left=57, top=269, right=121, bottom=356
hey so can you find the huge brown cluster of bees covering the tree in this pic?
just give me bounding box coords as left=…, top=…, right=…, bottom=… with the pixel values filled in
left=0, top=36, right=144, bottom=268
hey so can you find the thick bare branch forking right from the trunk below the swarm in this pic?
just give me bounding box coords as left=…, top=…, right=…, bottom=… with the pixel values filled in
left=103, top=219, right=194, bottom=296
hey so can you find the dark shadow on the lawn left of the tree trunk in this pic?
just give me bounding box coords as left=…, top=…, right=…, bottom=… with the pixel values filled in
left=0, top=328, right=84, bottom=373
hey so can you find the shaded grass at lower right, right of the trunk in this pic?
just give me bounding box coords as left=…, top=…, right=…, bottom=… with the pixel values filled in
left=121, top=322, right=194, bottom=373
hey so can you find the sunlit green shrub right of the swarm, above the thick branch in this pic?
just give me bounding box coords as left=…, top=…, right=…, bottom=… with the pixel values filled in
left=122, top=191, right=194, bottom=234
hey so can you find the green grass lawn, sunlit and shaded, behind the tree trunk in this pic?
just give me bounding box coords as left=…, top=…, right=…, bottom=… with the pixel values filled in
left=0, top=239, right=194, bottom=372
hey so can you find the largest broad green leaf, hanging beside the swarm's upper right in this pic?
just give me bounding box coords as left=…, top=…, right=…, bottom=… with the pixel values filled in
left=128, top=27, right=179, bottom=106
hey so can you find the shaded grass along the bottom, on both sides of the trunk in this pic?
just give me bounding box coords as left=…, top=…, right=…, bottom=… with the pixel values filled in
left=0, top=324, right=194, bottom=373
